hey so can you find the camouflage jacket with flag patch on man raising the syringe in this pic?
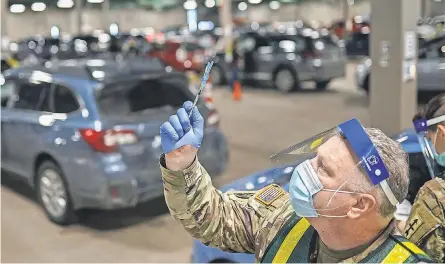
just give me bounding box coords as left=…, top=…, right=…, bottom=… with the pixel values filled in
left=160, top=157, right=416, bottom=263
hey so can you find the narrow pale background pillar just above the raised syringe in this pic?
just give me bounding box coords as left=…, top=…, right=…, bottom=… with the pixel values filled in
left=219, top=0, right=233, bottom=62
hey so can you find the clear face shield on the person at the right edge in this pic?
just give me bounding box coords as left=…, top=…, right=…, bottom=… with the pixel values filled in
left=413, top=115, right=445, bottom=178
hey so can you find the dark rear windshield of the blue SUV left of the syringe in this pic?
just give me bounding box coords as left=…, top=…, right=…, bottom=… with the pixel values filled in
left=96, top=80, right=188, bottom=116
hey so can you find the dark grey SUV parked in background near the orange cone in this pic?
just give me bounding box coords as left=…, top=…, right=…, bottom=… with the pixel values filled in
left=212, top=28, right=346, bottom=93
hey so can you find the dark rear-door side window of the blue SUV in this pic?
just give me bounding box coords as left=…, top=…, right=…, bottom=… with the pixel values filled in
left=14, top=83, right=50, bottom=111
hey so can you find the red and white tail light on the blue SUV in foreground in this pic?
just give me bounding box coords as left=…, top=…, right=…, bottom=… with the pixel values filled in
left=79, top=128, right=138, bottom=153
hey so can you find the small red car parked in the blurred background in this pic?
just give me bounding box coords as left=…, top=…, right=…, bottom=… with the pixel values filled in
left=149, top=40, right=205, bottom=72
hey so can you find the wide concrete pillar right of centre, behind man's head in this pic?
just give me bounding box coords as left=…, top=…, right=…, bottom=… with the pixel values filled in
left=370, top=0, right=420, bottom=135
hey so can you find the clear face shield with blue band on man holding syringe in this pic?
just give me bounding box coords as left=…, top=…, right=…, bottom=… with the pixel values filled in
left=270, top=119, right=398, bottom=217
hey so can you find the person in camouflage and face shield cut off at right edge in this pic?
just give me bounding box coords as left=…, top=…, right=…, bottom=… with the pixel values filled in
left=404, top=94, right=445, bottom=263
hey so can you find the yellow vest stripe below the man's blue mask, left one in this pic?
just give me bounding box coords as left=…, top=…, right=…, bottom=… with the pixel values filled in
left=272, top=218, right=311, bottom=263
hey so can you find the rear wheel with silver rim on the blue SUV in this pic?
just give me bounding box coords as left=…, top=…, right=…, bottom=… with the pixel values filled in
left=36, top=160, right=77, bottom=226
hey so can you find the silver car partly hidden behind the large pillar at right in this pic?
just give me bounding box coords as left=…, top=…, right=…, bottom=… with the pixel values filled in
left=355, top=35, right=445, bottom=93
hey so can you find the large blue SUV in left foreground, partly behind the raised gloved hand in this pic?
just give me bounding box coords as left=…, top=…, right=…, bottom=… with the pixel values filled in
left=1, top=58, right=228, bottom=225
